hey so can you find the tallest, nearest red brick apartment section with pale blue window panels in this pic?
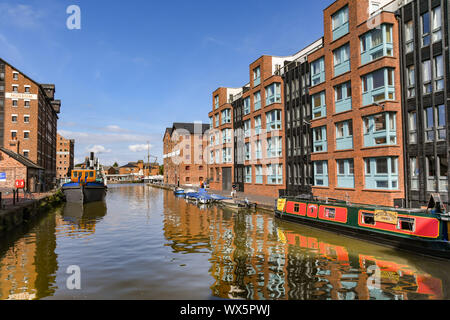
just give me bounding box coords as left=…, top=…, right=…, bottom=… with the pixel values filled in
left=308, top=0, right=404, bottom=205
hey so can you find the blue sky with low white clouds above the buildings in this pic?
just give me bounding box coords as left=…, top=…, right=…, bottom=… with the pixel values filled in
left=0, top=0, right=332, bottom=165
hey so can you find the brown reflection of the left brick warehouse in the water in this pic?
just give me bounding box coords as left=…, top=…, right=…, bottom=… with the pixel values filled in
left=0, top=208, right=58, bottom=300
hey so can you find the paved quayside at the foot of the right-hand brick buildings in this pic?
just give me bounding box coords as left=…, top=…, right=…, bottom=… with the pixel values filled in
left=147, top=183, right=277, bottom=212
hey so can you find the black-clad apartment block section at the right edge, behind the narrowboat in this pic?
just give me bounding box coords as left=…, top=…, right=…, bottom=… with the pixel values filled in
left=398, top=0, right=450, bottom=207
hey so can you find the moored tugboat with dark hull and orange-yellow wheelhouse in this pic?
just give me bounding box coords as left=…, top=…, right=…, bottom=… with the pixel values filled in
left=62, top=153, right=108, bottom=203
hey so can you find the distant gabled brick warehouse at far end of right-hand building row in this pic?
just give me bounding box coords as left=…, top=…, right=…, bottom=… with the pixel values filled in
left=163, top=123, right=209, bottom=186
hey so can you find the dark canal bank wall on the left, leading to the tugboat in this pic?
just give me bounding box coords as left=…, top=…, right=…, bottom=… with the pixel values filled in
left=0, top=190, right=64, bottom=236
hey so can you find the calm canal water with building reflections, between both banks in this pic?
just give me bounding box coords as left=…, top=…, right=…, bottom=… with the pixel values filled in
left=0, top=185, right=450, bottom=300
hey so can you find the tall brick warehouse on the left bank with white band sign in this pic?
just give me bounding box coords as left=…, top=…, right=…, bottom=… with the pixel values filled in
left=0, top=59, right=61, bottom=190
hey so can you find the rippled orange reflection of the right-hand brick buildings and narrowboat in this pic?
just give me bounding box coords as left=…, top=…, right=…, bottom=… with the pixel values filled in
left=164, top=192, right=444, bottom=300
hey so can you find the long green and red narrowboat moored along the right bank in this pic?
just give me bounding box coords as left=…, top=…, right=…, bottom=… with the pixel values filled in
left=275, top=195, right=450, bottom=259
